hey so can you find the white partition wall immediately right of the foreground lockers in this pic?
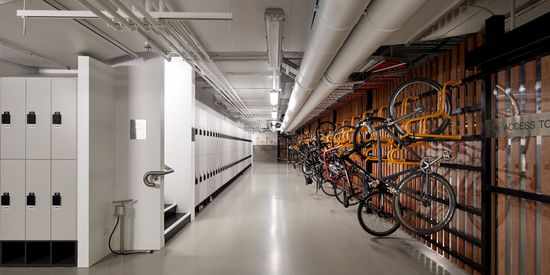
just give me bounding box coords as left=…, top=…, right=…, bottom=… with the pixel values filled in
left=77, top=56, right=115, bottom=267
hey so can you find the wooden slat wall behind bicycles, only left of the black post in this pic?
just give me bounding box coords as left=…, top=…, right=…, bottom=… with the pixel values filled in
left=298, top=34, right=488, bottom=274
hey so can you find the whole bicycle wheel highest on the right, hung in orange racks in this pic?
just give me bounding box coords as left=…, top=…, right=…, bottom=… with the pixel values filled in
left=388, top=78, right=451, bottom=134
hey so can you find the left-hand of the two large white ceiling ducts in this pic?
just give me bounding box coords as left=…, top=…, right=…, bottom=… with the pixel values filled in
left=283, top=0, right=369, bottom=130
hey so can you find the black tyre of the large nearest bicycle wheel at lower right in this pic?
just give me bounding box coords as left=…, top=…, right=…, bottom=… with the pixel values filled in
left=393, top=172, right=456, bottom=235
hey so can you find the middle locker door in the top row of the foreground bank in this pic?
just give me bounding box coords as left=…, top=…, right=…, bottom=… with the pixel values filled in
left=26, top=78, right=51, bottom=159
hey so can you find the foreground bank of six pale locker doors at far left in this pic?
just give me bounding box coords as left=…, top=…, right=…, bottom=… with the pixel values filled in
left=0, top=77, right=77, bottom=240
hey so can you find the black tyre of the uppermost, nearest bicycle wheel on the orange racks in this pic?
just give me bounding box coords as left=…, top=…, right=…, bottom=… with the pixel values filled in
left=388, top=78, right=451, bottom=135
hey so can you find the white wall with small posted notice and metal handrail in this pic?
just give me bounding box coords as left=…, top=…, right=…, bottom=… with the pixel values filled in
left=115, top=57, right=164, bottom=253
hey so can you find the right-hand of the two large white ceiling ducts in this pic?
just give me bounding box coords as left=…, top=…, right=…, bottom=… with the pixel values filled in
left=283, top=0, right=426, bottom=131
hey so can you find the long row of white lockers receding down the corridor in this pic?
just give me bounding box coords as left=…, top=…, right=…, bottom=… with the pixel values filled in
left=195, top=101, right=252, bottom=205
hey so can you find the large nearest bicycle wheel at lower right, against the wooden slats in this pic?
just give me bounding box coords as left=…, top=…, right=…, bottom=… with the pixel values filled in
left=393, top=172, right=456, bottom=235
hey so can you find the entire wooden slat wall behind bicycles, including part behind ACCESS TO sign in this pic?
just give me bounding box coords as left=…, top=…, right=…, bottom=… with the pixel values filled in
left=296, top=31, right=550, bottom=274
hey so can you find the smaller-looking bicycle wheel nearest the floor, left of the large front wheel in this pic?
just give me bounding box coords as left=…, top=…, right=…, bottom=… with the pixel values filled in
left=357, top=190, right=399, bottom=237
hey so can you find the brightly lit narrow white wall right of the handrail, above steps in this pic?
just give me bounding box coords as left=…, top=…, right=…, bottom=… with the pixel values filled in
left=164, top=58, right=195, bottom=219
